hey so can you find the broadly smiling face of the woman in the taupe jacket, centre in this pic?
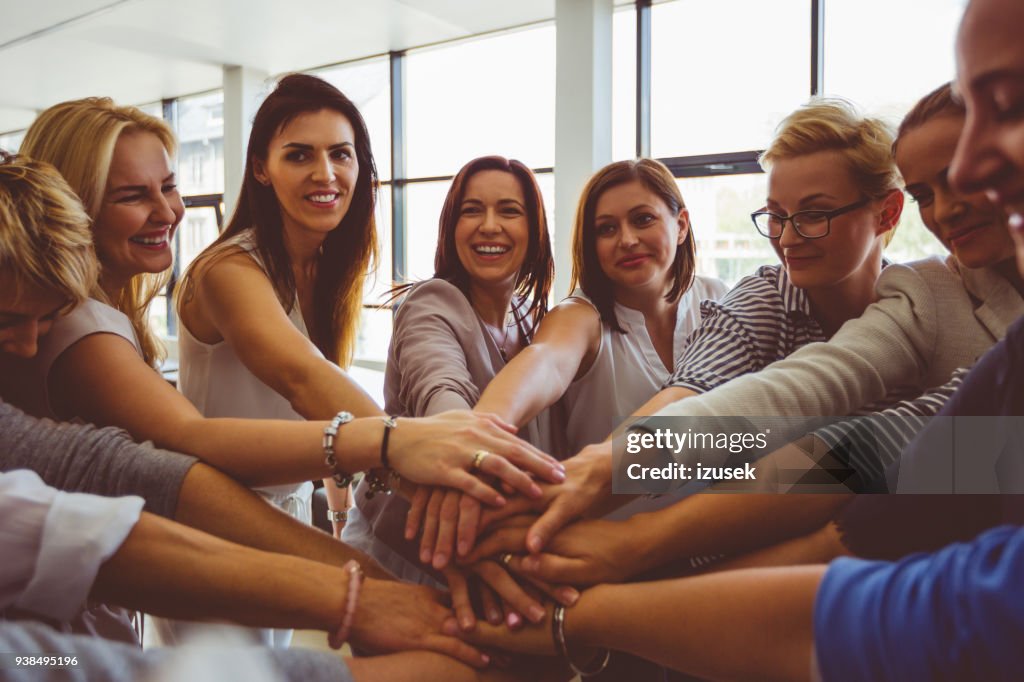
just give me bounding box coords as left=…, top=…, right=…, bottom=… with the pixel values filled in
left=455, top=170, right=530, bottom=289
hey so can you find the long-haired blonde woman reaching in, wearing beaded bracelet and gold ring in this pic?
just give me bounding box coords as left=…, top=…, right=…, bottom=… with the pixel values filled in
left=0, top=91, right=558, bottom=643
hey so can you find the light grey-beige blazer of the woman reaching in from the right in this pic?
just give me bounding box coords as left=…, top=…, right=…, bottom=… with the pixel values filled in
left=658, top=256, right=1024, bottom=417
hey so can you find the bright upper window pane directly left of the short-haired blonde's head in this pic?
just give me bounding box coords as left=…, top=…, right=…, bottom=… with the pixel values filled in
left=650, top=0, right=810, bottom=157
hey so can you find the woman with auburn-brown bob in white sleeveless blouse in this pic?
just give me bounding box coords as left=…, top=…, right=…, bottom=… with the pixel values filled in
left=406, top=159, right=726, bottom=585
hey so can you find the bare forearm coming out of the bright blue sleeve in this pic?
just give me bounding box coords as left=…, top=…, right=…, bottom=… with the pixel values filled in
left=566, top=566, right=824, bottom=680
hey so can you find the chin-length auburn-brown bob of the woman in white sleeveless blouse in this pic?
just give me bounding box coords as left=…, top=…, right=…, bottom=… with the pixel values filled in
left=569, top=159, right=696, bottom=333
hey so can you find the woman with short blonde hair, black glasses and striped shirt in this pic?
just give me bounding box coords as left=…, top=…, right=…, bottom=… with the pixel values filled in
left=448, top=99, right=903, bottom=550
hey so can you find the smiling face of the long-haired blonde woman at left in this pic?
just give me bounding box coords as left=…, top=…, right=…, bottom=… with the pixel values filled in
left=93, top=132, right=185, bottom=287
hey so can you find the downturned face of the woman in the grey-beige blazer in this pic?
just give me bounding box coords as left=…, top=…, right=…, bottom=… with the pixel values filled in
left=896, top=115, right=1014, bottom=267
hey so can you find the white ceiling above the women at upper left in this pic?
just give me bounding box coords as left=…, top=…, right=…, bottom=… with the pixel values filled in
left=0, top=0, right=555, bottom=132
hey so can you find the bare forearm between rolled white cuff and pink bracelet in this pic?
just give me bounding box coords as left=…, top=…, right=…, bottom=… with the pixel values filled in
left=92, top=514, right=347, bottom=630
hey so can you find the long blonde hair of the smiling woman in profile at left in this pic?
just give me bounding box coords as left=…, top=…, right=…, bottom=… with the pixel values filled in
left=22, top=97, right=177, bottom=365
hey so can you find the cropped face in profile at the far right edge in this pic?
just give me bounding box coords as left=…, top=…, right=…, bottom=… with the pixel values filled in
left=950, top=0, right=1024, bottom=271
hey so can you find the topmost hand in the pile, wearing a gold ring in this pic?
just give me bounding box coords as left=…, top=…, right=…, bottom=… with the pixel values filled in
left=389, top=410, right=565, bottom=507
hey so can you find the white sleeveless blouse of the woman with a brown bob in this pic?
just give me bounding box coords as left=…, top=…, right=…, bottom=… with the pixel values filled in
left=562, top=275, right=729, bottom=454
